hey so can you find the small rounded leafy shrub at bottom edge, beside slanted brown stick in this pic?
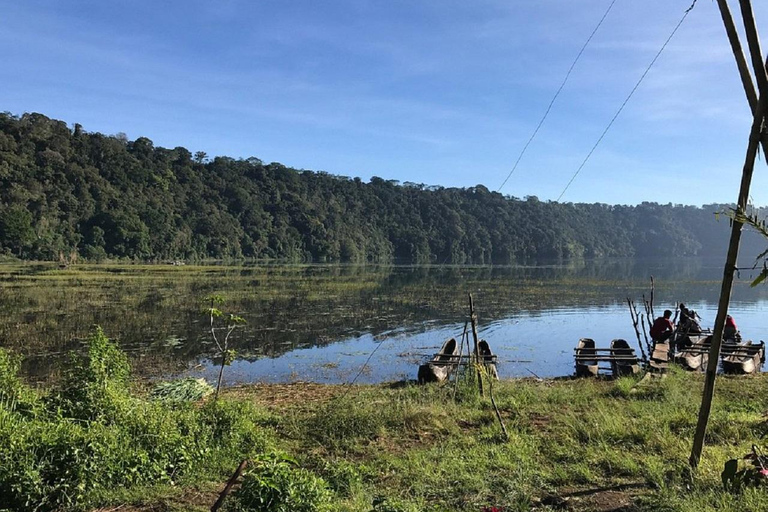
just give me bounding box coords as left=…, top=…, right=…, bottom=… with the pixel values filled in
left=230, top=456, right=331, bottom=512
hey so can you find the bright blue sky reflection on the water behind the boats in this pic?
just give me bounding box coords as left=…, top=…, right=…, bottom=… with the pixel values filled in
left=190, top=300, right=768, bottom=384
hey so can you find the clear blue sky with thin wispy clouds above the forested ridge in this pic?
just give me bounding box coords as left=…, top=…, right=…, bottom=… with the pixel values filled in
left=0, top=0, right=768, bottom=204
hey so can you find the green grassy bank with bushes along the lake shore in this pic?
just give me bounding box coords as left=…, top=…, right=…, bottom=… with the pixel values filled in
left=0, top=332, right=768, bottom=512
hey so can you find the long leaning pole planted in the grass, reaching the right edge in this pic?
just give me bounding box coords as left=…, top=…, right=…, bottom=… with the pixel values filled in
left=688, top=58, right=768, bottom=469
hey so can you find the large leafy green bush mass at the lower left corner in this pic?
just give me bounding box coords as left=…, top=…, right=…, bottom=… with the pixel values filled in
left=0, top=329, right=269, bottom=512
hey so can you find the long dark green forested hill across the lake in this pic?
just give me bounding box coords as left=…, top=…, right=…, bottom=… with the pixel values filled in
left=0, top=113, right=762, bottom=264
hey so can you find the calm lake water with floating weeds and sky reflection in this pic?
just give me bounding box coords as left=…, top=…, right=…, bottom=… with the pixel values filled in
left=0, top=259, right=768, bottom=384
